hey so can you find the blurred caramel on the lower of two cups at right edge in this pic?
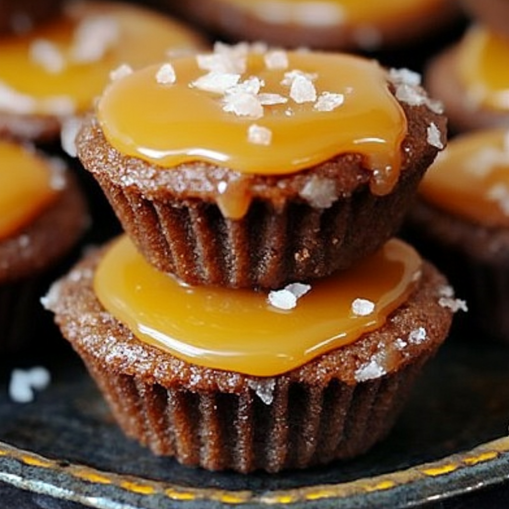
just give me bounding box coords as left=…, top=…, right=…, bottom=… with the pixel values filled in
left=419, top=129, right=509, bottom=227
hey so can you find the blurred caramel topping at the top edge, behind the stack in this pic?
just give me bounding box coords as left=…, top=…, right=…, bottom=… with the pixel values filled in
left=224, top=0, right=444, bottom=26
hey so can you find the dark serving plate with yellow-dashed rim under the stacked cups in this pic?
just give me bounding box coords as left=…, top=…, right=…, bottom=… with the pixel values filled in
left=0, top=320, right=509, bottom=509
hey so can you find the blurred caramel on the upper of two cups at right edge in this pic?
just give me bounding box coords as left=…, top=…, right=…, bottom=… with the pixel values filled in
left=458, top=26, right=509, bottom=111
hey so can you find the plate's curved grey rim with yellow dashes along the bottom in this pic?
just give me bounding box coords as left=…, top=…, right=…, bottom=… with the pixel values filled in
left=0, top=436, right=509, bottom=509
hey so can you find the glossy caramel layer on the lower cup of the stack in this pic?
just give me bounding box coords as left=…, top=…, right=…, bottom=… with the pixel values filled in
left=94, top=236, right=421, bottom=376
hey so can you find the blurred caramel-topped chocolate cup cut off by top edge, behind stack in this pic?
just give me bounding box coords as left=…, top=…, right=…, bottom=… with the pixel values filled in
left=163, top=0, right=458, bottom=50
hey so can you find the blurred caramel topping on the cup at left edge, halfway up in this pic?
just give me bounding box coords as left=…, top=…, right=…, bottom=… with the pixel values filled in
left=0, top=141, right=57, bottom=240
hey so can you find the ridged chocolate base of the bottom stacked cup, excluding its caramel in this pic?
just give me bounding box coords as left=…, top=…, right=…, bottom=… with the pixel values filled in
left=45, top=238, right=455, bottom=473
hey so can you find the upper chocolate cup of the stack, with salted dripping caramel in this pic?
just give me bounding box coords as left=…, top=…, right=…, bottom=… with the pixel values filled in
left=77, top=46, right=446, bottom=288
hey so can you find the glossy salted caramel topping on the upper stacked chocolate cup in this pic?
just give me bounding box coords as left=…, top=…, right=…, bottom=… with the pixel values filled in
left=97, top=44, right=407, bottom=207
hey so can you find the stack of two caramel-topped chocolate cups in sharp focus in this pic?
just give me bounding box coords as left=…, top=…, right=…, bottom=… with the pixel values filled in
left=46, top=44, right=457, bottom=473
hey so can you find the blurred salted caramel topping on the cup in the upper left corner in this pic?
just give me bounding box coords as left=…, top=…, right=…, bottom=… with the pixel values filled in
left=0, top=2, right=203, bottom=115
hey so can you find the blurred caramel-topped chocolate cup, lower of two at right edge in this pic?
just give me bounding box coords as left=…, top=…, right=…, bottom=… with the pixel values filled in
left=407, top=128, right=509, bottom=342
